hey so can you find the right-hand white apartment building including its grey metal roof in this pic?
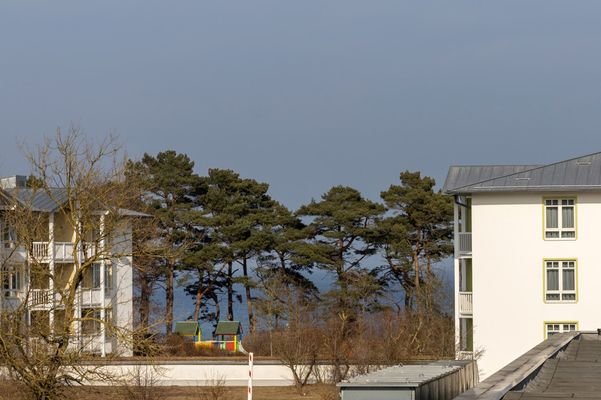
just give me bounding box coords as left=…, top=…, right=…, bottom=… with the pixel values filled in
left=443, top=153, right=601, bottom=378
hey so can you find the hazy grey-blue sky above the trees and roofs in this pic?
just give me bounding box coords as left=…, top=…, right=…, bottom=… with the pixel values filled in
left=0, top=0, right=601, bottom=208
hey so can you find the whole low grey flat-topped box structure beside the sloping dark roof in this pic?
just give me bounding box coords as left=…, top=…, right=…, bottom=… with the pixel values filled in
left=338, top=361, right=478, bottom=400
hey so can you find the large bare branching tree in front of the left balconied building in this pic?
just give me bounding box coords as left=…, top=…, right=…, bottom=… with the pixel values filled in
left=0, top=127, right=146, bottom=400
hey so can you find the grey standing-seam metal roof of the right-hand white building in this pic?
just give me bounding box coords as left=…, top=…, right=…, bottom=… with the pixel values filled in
left=443, top=152, right=601, bottom=194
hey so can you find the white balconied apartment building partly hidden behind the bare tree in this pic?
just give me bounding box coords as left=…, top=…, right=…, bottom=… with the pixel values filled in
left=0, top=176, right=137, bottom=356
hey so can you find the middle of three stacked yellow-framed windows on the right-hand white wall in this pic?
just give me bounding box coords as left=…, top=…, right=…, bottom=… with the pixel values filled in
left=545, top=260, right=576, bottom=302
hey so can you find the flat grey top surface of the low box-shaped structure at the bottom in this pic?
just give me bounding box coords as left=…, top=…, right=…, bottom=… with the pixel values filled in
left=338, top=361, right=469, bottom=387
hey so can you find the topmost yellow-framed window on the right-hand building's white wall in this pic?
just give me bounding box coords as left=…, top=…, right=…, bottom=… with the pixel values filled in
left=545, top=199, right=576, bottom=239
